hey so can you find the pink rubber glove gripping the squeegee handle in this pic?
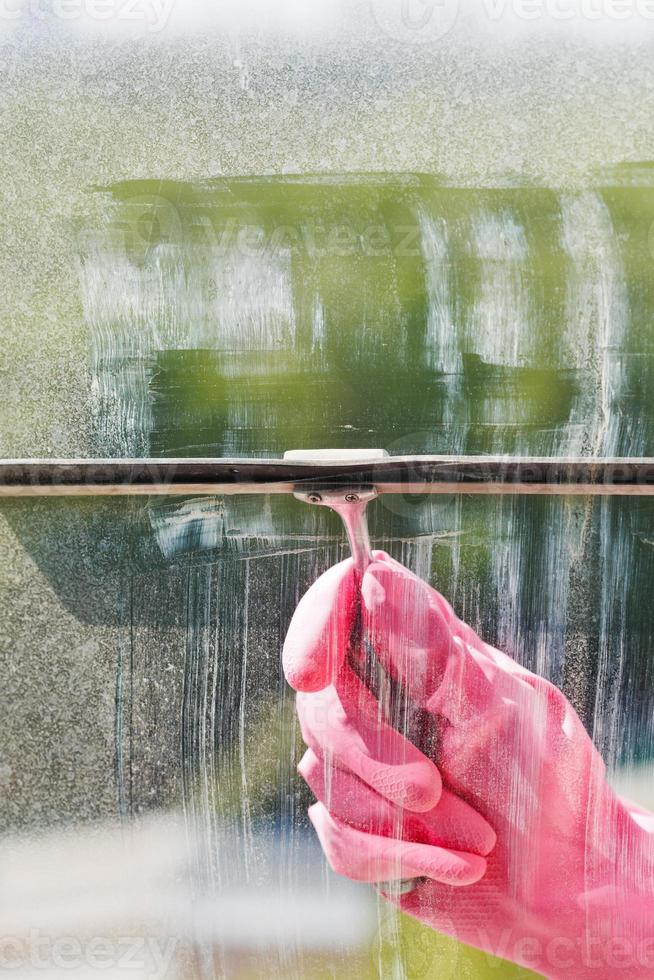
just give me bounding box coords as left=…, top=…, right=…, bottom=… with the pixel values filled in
left=284, top=552, right=654, bottom=980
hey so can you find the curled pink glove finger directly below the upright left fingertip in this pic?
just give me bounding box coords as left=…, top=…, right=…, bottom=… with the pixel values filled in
left=297, top=668, right=442, bottom=812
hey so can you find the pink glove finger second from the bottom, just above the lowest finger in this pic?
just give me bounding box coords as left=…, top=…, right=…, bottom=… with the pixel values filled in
left=298, top=749, right=495, bottom=856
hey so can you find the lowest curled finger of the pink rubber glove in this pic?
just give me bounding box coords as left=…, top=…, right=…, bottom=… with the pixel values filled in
left=309, top=803, right=486, bottom=887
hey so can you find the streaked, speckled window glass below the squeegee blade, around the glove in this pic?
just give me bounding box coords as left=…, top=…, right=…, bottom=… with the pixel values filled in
left=0, top=486, right=654, bottom=977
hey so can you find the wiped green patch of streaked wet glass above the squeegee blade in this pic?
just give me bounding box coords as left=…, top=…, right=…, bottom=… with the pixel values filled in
left=81, top=175, right=654, bottom=456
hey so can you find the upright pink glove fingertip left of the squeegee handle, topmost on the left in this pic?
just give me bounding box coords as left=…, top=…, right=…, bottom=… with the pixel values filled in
left=282, top=558, right=356, bottom=691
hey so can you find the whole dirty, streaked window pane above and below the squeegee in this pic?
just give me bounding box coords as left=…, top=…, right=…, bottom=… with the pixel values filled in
left=0, top=11, right=654, bottom=980
